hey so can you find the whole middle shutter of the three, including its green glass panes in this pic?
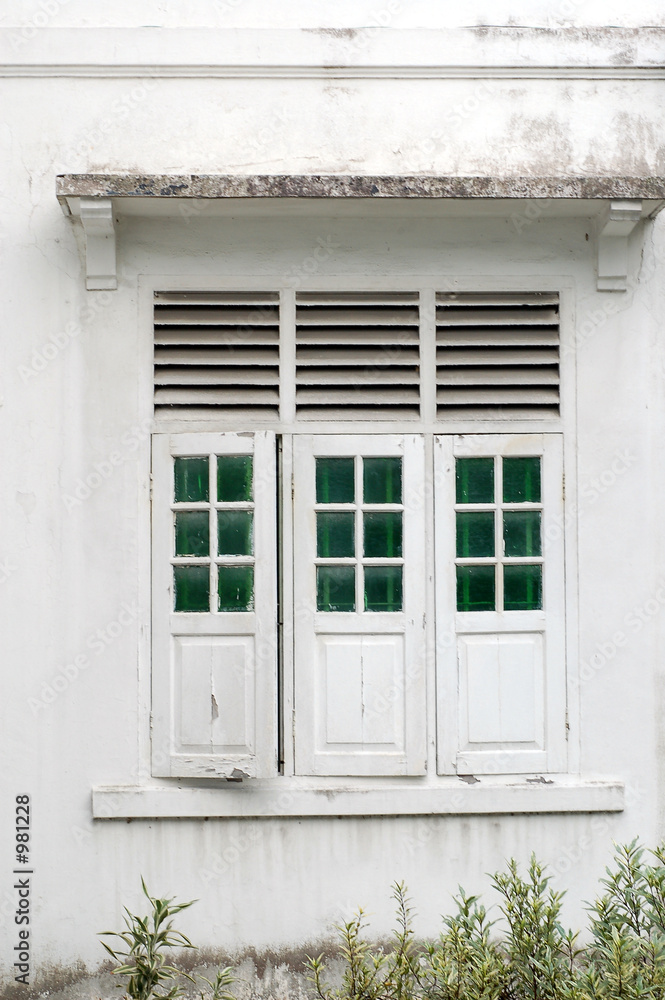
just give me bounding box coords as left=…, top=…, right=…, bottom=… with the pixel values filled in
left=293, top=435, right=427, bottom=776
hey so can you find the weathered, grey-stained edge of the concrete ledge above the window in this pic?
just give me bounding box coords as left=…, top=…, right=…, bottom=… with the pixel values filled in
left=56, top=174, right=665, bottom=202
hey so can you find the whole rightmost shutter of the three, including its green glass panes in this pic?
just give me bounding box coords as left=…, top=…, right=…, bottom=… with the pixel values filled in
left=435, top=434, right=567, bottom=774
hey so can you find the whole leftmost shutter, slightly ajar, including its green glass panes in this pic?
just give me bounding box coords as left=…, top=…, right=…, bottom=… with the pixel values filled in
left=152, top=433, right=277, bottom=780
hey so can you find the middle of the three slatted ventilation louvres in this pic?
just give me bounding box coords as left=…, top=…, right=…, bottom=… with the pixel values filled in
left=296, top=292, right=420, bottom=420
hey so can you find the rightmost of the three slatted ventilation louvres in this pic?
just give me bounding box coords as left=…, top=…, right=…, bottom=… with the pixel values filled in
left=436, top=293, right=559, bottom=419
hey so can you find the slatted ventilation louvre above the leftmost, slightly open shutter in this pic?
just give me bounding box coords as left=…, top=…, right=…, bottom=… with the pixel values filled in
left=155, top=292, right=279, bottom=419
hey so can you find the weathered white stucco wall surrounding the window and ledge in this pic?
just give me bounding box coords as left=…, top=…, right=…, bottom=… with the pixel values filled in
left=0, top=0, right=665, bottom=992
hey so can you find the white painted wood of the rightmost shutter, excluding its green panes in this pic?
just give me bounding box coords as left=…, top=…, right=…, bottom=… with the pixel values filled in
left=435, top=435, right=566, bottom=774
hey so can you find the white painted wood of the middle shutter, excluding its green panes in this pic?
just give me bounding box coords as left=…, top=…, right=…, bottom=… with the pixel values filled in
left=293, top=435, right=426, bottom=775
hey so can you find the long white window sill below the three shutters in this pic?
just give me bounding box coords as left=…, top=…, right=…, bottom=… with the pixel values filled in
left=92, top=777, right=624, bottom=819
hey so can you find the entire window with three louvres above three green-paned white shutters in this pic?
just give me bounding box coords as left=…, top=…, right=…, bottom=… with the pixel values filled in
left=153, top=289, right=566, bottom=783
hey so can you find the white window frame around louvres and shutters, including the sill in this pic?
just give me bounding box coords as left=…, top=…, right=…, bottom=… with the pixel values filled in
left=93, top=274, right=623, bottom=817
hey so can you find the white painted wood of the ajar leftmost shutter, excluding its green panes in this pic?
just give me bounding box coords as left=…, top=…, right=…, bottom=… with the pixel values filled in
left=153, top=432, right=277, bottom=778
